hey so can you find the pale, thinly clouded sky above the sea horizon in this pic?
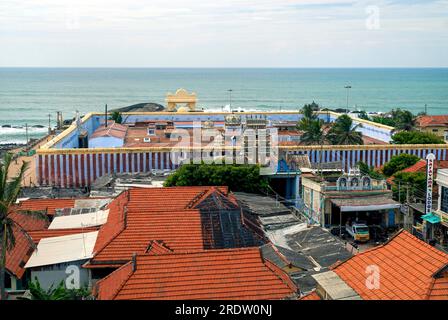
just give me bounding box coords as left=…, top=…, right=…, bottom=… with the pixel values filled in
left=0, top=0, right=448, bottom=68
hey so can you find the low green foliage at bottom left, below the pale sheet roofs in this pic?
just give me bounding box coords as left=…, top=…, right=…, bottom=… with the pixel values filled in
left=28, top=278, right=91, bottom=300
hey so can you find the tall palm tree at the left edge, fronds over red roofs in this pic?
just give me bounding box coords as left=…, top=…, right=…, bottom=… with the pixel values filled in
left=0, top=153, right=47, bottom=300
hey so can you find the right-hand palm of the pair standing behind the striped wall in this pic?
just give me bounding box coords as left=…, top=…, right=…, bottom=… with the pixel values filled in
left=327, top=114, right=364, bottom=145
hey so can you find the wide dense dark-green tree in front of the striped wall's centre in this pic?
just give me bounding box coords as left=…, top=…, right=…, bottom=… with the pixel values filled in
left=164, top=164, right=268, bottom=193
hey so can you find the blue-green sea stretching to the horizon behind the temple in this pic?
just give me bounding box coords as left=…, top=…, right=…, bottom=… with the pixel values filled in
left=0, top=68, right=448, bottom=144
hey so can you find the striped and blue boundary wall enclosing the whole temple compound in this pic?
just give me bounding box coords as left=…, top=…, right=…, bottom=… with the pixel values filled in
left=36, top=112, right=448, bottom=187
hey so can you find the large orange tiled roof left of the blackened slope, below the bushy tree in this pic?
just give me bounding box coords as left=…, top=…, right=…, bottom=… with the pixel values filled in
left=87, top=187, right=233, bottom=267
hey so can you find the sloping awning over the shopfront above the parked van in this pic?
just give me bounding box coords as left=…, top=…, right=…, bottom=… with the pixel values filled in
left=331, top=197, right=400, bottom=212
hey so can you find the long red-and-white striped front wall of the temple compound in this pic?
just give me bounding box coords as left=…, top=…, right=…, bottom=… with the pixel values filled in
left=36, top=145, right=448, bottom=188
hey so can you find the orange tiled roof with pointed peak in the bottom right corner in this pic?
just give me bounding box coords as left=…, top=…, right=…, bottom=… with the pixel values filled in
left=333, top=231, right=448, bottom=300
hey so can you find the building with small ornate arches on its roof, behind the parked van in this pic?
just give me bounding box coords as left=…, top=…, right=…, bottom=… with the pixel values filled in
left=301, top=169, right=403, bottom=227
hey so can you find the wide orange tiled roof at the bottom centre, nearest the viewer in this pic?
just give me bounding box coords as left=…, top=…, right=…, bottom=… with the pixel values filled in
left=96, top=248, right=297, bottom=300
